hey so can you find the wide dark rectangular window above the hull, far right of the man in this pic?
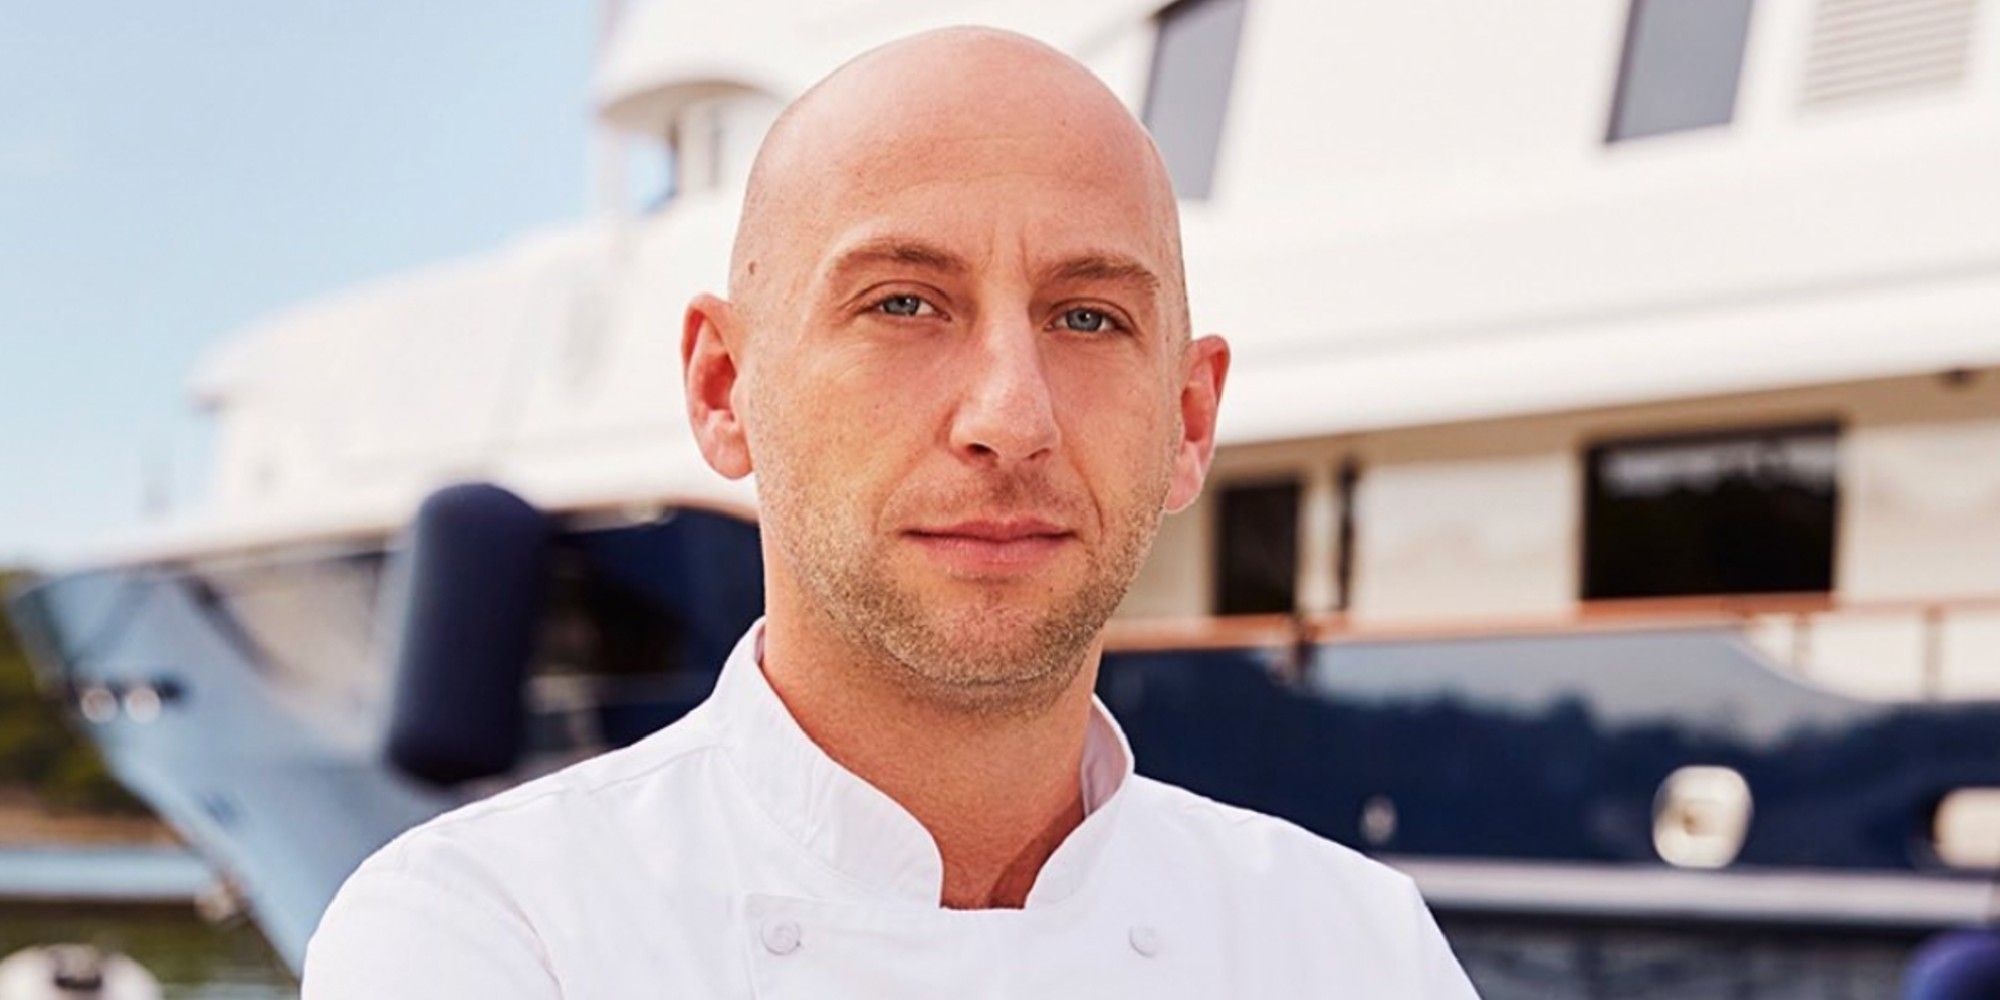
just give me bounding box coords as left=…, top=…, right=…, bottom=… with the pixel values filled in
left=1584, top=424, right=1840, bottom=598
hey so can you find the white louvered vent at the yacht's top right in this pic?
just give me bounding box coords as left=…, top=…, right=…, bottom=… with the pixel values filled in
left=1800, top=0, right=1980, bottom=108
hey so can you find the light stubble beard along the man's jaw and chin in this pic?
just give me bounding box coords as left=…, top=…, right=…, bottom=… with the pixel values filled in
left=762, top=456, right=1168, bottom=716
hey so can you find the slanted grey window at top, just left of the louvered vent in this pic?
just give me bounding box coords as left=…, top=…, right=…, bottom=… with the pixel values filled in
left=1610, top=0, right=1750, bottom=142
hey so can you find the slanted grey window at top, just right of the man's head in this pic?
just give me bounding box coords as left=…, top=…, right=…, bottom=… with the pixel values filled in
left=1142, top=0, right=1246, bottom=198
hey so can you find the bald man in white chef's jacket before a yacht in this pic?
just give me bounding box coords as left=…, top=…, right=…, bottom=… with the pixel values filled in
left=306, top=30, right=1472, bottom=1000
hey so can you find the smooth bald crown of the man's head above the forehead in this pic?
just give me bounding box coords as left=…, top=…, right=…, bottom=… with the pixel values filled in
left=730, top=28, right=1186, bottom=338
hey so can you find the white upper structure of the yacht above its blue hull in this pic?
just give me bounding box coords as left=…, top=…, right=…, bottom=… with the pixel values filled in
left=172, top=0, right=2000, bottom=696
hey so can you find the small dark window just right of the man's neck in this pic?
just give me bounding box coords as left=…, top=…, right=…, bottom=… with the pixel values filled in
left=1216, top=480, right=1302, bottom=614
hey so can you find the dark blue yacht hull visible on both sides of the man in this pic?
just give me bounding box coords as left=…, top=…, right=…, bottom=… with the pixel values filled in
left=12, top=514, right=2000, bottom=984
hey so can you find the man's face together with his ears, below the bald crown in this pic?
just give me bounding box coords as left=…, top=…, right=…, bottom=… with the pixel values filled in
left=688, top=43, right=1226, bottom=710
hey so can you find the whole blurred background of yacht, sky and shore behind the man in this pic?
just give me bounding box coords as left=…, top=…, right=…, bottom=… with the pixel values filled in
left=0, top=0, right=2000, bottom=1000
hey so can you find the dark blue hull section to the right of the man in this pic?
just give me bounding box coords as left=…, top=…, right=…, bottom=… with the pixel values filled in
left=1100, top=628, right=2000, bottom=874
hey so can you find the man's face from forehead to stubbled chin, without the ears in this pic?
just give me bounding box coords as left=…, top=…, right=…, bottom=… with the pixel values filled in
left=750, top=191, right=1182, bottom=704
